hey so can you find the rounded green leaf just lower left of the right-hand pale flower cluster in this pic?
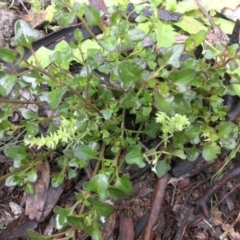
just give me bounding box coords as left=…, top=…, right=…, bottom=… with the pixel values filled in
left=125, top=146, right=145, bottom=168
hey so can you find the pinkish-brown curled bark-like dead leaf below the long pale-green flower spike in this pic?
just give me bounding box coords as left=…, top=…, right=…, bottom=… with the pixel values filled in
left=25, top=161, right=50, bottom=222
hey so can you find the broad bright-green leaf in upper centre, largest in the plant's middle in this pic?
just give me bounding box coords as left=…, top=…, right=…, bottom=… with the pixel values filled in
left=117, top=60, right=146, bottom=90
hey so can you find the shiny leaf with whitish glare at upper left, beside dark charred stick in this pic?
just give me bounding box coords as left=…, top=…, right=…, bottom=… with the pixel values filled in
left=11, top=20, right=39, bottom=48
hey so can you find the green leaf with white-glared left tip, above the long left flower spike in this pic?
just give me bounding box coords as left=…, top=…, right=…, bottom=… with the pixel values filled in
left=39, top=87, right=66, bottom=110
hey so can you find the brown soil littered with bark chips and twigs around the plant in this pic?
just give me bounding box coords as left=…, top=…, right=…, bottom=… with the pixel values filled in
left=0, top=1, right=240, bottom=240
